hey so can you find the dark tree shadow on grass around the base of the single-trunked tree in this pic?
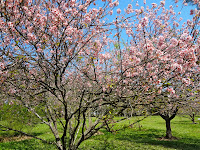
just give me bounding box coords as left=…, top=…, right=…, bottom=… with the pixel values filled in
left=116, top=129, right=200, bottom=150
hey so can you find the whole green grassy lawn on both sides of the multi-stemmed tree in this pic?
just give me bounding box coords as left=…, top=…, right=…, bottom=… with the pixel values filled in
left=0, top=116, right=200, bottom=150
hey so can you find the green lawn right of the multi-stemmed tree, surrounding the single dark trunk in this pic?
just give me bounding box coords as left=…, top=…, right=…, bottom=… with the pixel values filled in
left=80, top=116, right=200, bottom=150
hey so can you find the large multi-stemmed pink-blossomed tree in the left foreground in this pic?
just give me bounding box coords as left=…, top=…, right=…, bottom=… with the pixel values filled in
left=0, top=0, right=126, bottom=150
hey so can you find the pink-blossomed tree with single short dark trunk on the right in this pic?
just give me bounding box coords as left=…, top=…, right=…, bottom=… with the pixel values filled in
left=109, top=1, right=200, bottom=139
